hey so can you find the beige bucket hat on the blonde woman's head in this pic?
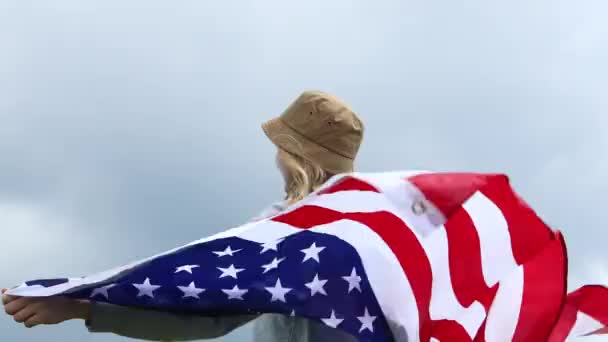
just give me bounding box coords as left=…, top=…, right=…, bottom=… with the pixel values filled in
left=262, top=91, right=363, bottom=174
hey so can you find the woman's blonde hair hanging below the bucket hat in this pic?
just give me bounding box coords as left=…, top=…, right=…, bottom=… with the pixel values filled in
left=278, top=148, right=333, bottom=204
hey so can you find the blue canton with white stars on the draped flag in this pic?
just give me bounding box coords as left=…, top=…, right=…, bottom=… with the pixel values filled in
left=26, top=231, right=392, bottom=341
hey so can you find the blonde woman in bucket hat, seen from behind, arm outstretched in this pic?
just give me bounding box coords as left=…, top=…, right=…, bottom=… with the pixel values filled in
left=2, top=91, right=363, bottom=342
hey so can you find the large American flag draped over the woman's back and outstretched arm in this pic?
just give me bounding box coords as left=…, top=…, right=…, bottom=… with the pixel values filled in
left=9, top=171, right=608, bottom=342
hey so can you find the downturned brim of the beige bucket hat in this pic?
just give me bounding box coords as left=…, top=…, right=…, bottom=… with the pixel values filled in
left=262, top=117, right=353, bottom=174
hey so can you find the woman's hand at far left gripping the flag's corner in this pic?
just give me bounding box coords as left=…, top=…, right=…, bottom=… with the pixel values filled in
left=2, top=289, right=90, bottom=328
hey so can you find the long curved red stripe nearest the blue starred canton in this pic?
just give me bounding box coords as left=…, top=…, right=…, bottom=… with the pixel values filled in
left=273, top=206, right=433, bottom=342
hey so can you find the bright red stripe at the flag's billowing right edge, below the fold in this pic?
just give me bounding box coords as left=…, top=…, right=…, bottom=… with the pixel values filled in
left=513, top=233, right=568, bottom=341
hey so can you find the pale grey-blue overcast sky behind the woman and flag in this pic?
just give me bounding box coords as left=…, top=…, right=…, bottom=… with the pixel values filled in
left=0, top=0, right=608, bottom=342
